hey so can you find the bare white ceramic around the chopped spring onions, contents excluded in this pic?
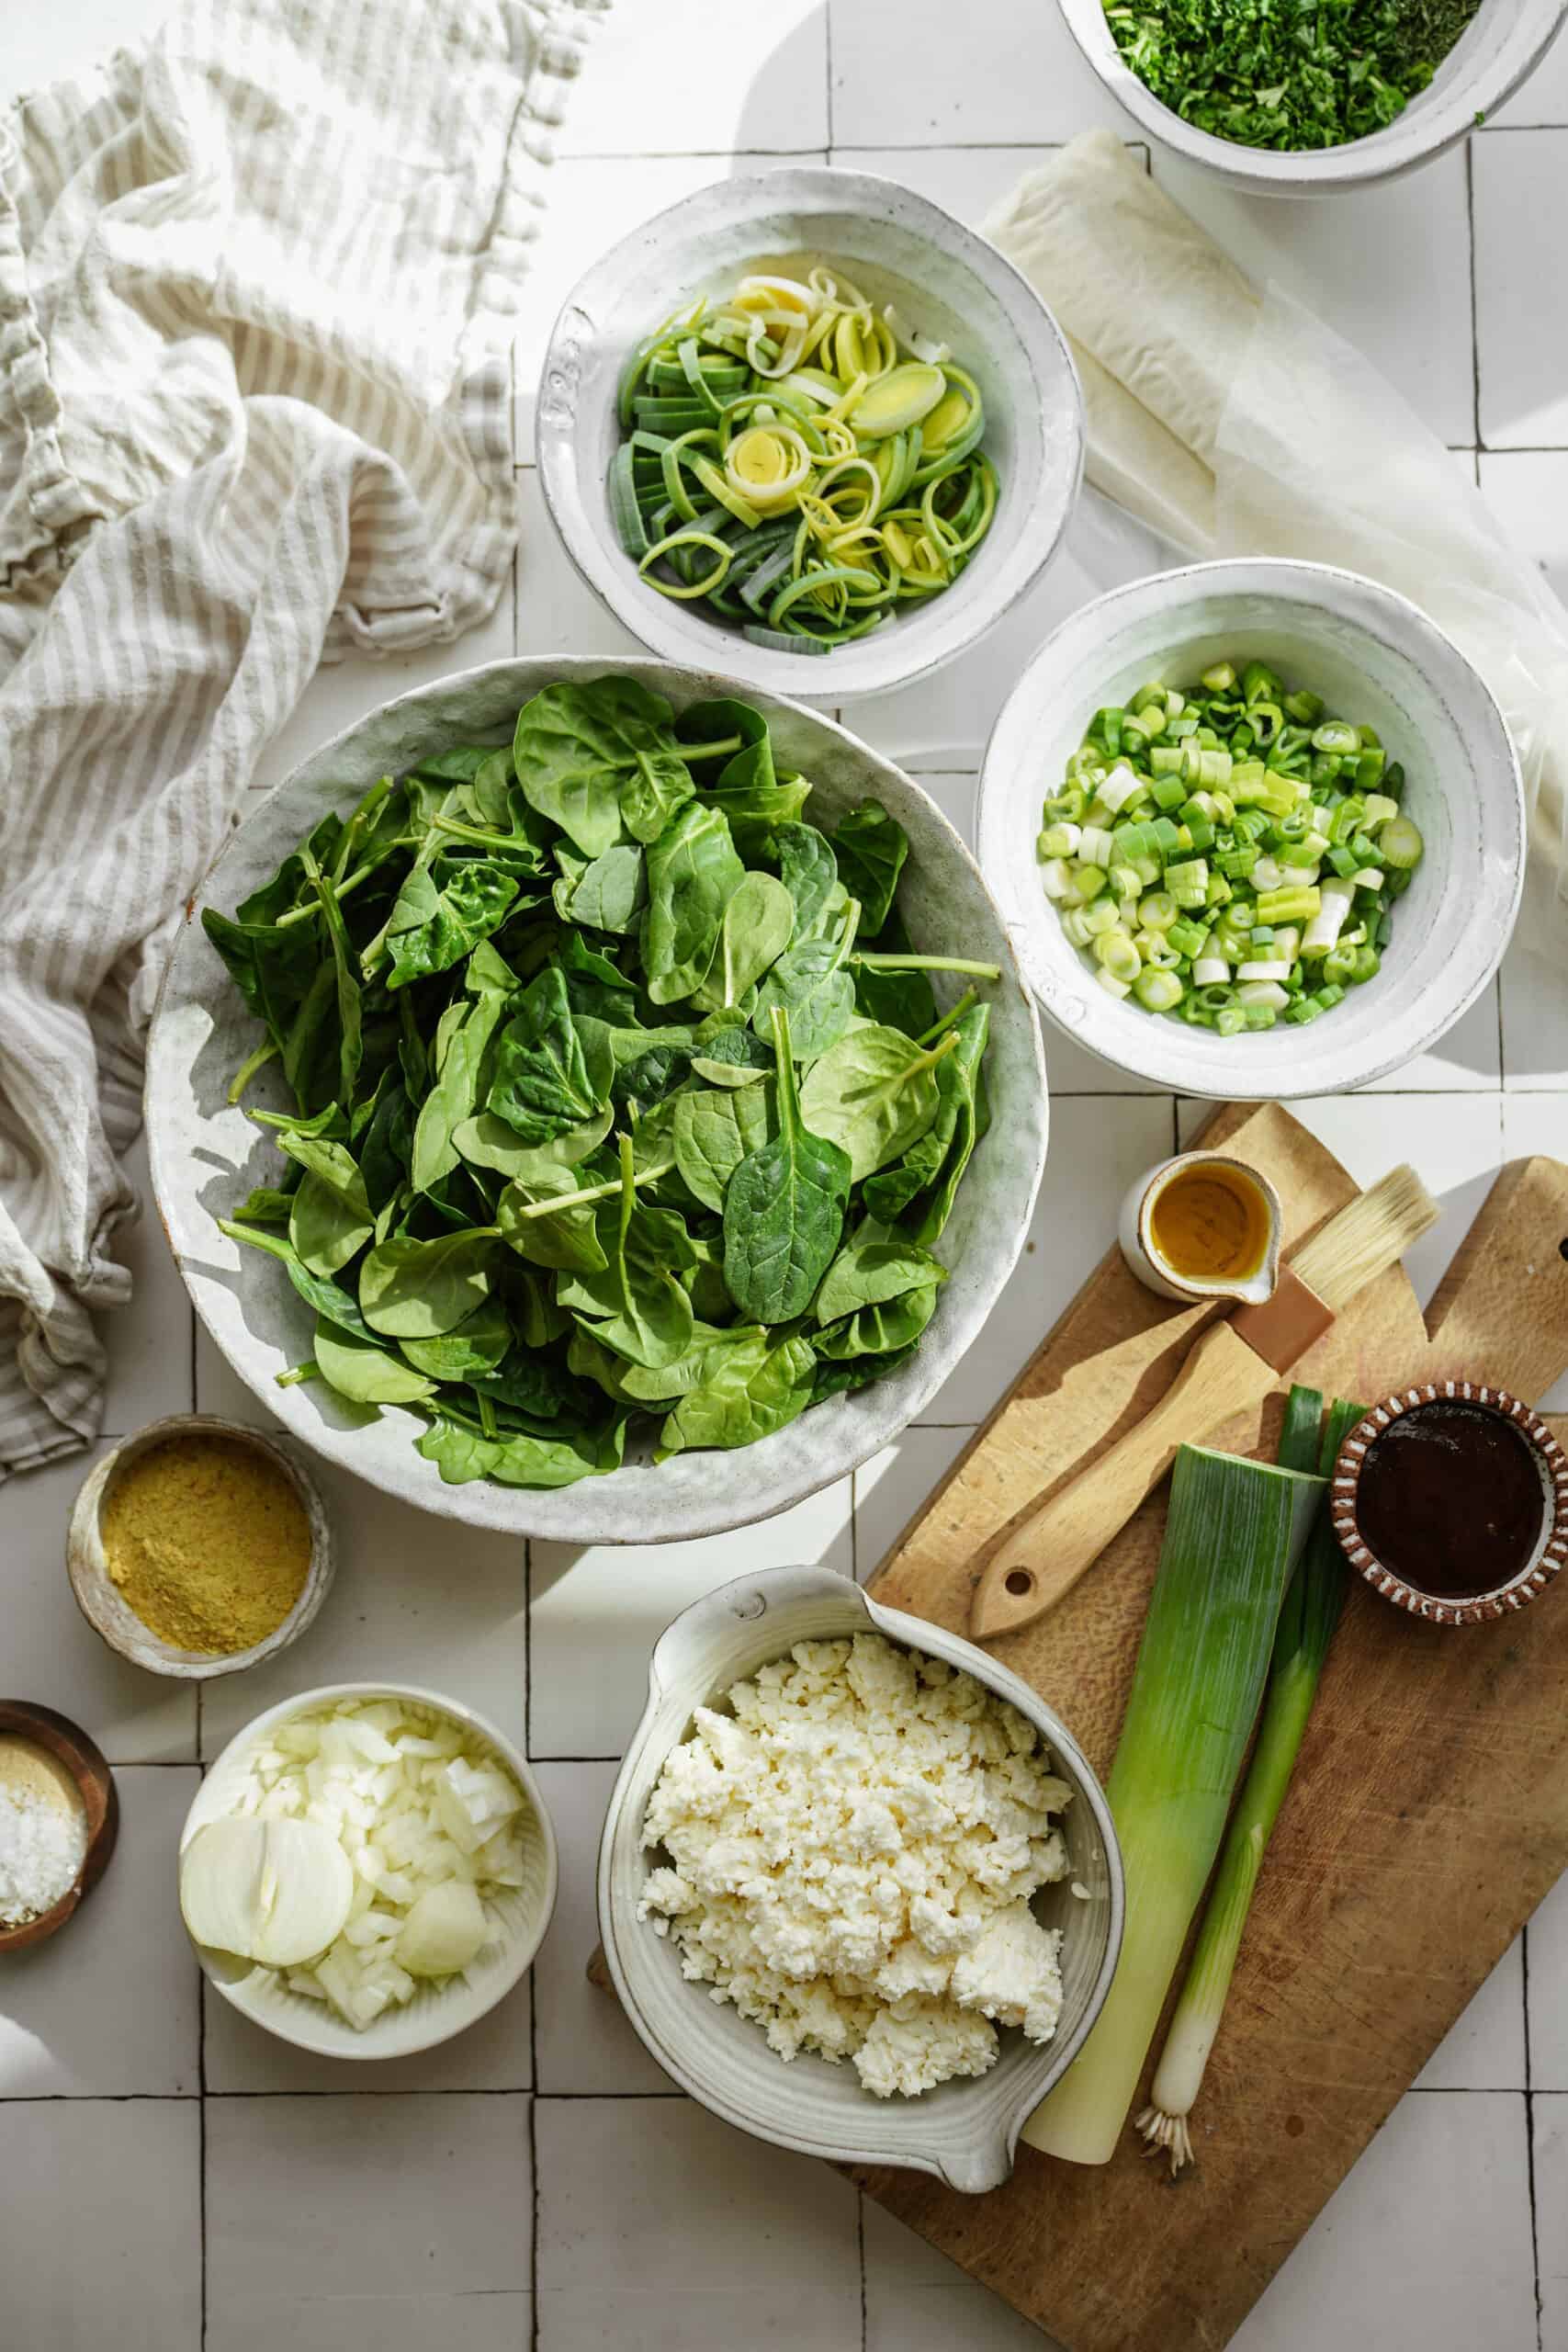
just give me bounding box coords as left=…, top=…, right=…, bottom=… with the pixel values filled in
left=978, top=558, right=1526, bottom=1101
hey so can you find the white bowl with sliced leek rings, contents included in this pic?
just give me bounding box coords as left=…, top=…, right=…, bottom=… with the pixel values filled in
left=538, top=169, right=1084, bottom=703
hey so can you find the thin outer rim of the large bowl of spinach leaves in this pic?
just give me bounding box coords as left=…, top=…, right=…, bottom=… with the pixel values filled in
left=143, top=651, right=1051, bottom=1545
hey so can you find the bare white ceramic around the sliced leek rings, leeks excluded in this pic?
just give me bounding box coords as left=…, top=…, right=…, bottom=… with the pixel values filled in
left=536, top=167, right=1084, bottom=703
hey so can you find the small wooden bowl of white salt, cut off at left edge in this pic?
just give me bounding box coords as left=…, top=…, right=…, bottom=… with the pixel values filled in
left=0, top=1698, right=120, bottom=1952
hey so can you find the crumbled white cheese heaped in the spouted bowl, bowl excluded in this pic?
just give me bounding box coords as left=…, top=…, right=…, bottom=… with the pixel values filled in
left=637, top=1634, right=1069, bottom=2098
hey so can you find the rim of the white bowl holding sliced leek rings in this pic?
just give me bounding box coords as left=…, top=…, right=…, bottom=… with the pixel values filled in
left=536, top=161, right=1086, bottom=706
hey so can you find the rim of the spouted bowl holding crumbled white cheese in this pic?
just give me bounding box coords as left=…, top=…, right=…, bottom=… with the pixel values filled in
left=594, top=1566, right=1126, bottom=2192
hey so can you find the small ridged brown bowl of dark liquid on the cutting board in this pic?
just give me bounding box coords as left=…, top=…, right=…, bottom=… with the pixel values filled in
left=1331, top=1381, right=1568, bottom=1625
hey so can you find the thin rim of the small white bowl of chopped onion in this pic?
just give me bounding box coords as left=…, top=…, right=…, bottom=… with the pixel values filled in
left=174, top=1677, right=559, bottom=2063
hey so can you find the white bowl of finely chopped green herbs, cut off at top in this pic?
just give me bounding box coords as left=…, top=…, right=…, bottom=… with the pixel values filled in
left=1060, top=0, right=1568, bottom=195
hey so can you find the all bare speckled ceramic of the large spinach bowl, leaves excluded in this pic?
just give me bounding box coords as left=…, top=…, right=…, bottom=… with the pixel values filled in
left=146, top=661, right=1046, bottom=1543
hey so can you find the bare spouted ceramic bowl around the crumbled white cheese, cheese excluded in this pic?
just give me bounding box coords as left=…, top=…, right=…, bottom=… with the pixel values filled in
left=600, top=1569, right=1123, bottom=2192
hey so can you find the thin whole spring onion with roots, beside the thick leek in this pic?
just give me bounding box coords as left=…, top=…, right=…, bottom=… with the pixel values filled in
left=1138, top=1390, right=1366, bottom=2173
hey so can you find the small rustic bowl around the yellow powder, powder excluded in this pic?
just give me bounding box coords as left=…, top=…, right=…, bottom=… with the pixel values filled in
left=66, top=1414, right=333, bottom=1681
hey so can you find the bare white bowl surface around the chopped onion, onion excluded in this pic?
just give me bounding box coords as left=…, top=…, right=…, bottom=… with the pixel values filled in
left=179, top=1681, right=558, bottom=2058
